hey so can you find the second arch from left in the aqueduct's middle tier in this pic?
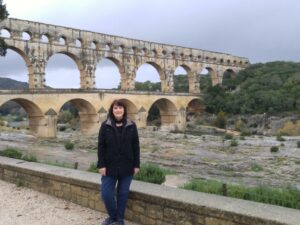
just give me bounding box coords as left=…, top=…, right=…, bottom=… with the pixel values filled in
left=45, top=51, right=85, bottom=87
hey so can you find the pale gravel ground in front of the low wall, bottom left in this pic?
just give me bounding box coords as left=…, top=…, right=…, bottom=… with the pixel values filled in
left=0, top=180, right=137, bottom=225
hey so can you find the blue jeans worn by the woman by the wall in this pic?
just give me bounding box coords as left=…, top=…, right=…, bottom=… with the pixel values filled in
left=101, top=176, right=133, bottom=221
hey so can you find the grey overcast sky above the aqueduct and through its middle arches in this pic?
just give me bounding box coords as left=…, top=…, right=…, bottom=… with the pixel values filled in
left=0, top=0, right=300, bottom=87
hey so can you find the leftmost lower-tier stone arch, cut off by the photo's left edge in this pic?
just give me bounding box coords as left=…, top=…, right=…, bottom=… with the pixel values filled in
left=1, top=98, right=47, bottom=136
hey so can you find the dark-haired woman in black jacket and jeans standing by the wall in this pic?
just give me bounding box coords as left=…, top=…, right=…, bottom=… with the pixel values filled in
left=97, top=100, right=140, bottom=225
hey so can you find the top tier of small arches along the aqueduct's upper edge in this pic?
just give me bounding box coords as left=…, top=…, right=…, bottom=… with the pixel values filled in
left=0, top=19, right=249, bottom=67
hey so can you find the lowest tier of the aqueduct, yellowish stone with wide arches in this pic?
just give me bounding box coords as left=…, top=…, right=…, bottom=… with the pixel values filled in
left=0, top=89, right=203, bottom=137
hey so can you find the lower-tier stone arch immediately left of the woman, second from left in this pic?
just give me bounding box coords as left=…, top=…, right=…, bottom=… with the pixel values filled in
left=58, top=98, right=99, bottom=134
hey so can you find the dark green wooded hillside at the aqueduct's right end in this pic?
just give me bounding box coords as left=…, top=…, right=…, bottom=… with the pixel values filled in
left=203, top=62, right=300, bottom=114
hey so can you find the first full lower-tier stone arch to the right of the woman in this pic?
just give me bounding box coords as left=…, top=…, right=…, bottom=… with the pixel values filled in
left=147, top=98, right=177, bottom=129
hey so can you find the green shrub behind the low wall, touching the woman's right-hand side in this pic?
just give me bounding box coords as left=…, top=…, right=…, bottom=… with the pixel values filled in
left=134, top=163, right=166, bottom=184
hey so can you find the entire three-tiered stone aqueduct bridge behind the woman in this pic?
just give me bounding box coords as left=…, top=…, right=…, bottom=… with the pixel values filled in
left=0, top=18, right=249, bottom=137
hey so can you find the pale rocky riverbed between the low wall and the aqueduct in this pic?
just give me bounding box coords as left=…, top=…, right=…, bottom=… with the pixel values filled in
left=0, top=128, right=300, bottom=189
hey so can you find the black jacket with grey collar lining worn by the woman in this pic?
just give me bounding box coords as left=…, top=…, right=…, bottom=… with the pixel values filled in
left=97, top=119, right=140, bottom=177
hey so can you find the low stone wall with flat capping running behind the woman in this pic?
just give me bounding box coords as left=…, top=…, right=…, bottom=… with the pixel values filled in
left=0, top=157, right=300, bottom=225
